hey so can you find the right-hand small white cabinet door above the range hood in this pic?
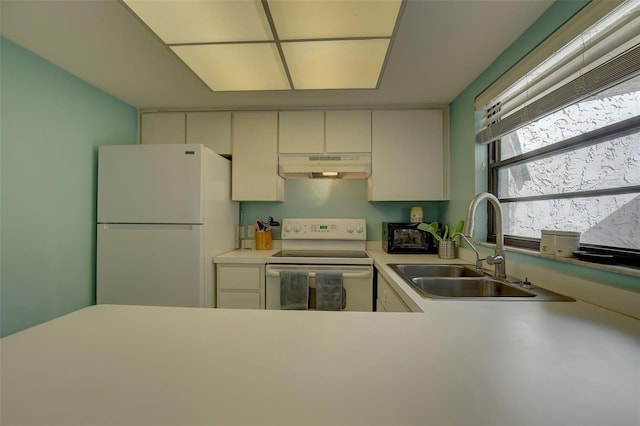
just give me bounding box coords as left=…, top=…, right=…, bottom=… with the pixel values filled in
left=325, top=110, right=371, bottom=152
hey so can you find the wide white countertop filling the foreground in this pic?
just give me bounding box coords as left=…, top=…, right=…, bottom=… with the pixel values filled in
left=0, top=302, right=640, bottom=426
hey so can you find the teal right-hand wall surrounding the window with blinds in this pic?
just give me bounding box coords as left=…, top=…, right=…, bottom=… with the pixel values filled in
left=450, top=0, right=640, bottom=291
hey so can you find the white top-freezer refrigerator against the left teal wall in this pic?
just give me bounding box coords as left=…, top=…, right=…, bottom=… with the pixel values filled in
left=96, top=144, right=238, bottom=307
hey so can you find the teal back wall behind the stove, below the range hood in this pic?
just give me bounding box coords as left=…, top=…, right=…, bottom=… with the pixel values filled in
left=240, top=179, right=444, bottom=241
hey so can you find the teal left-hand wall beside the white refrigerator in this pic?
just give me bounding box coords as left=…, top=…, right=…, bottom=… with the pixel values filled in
left=0, top=38, right=137, bottom=336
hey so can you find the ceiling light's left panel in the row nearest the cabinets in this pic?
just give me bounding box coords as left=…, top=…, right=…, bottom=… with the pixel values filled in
left=171, top=43, right=291, bottom=91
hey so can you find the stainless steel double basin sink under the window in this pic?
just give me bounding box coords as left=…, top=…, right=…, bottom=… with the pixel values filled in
left=389, top=263, right=575, bottom=302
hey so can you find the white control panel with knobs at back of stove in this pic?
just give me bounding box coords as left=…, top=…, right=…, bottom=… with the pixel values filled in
left=281, top=218, right=367, bottom=240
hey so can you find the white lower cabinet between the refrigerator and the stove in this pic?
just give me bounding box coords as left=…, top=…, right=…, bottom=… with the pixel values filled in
left=216, top=263, right=265, bottom=309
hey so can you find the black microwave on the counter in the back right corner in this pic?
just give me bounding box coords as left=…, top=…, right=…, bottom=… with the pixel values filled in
left=382, top=222, right=440, bottom=254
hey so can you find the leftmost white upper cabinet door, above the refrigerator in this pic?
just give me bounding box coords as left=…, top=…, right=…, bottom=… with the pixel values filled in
left=140, top=112, right=186, bottom=144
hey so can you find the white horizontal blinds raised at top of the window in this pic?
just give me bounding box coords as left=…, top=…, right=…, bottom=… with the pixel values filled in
left=476, top=0, right=640, bottom=143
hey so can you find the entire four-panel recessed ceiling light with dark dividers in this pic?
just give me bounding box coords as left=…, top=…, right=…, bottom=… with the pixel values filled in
left=120, top=0, right=406, bottom=91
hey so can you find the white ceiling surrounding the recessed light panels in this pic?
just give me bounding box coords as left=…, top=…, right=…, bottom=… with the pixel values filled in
left=0, top=0, right=553, bottom=110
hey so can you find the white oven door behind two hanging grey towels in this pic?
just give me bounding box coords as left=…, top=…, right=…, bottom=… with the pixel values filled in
left=265, top=264, right=373, bottom=312
